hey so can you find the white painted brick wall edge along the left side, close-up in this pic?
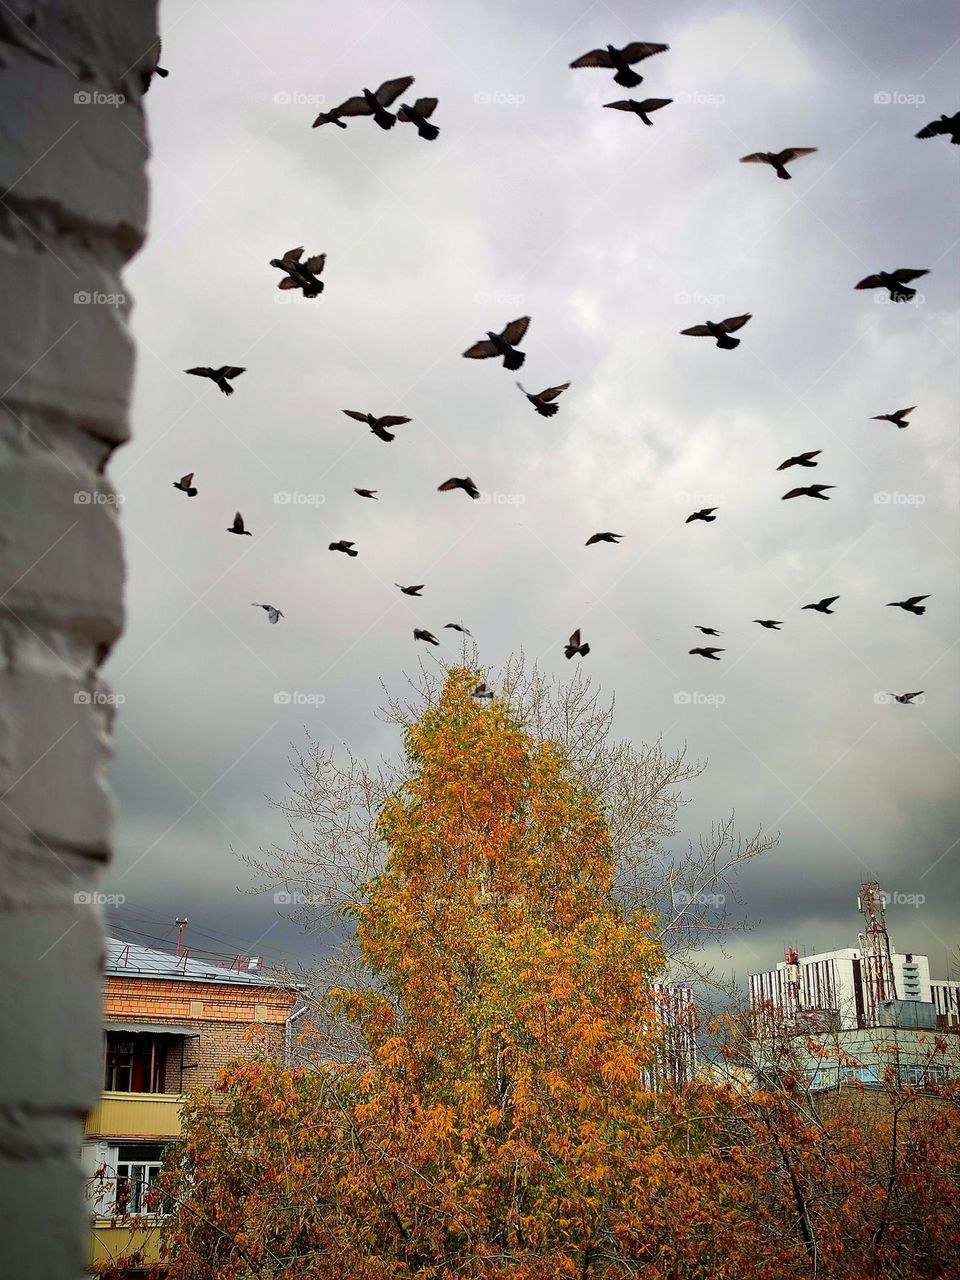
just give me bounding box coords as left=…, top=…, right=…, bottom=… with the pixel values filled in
left=0, top=0, right=163, bottom=1280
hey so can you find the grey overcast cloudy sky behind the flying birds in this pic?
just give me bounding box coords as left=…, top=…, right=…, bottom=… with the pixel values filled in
left=104, top=0, right=960, bottom=977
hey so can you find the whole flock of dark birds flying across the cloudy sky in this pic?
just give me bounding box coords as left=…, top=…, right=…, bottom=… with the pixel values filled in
left=155, top=41, right=960, bottom=705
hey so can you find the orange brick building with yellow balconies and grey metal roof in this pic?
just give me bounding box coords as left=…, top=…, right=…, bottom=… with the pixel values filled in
left=81, top=938, right=300, bottom=1274
